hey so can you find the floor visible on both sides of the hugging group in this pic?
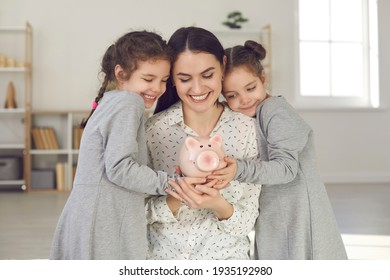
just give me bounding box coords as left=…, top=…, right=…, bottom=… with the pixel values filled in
left=0, top=184, right=390, bottom=260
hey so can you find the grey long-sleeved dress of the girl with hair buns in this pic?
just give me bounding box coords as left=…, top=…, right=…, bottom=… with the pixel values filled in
left=236, top=96, right=347, bottom=260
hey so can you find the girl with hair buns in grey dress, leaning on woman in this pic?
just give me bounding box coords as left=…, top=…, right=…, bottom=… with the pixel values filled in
left=209, top=41, right=347, bottom=260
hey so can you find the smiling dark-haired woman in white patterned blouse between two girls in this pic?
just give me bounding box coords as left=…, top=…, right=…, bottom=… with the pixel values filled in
left=146, top=27, right=260, bottom=259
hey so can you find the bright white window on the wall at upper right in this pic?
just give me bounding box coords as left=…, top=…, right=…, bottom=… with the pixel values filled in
left=298, top=0, right=379, bottom=107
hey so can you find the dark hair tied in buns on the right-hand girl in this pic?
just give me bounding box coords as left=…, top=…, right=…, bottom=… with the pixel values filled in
left=225, top=40, right=266, bottom=77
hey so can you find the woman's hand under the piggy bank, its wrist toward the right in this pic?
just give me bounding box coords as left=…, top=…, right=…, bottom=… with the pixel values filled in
left=167, top=178, right=234, bottom=220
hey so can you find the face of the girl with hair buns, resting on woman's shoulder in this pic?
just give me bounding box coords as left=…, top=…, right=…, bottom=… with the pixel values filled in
left=223, top=66, right=267, bottom=117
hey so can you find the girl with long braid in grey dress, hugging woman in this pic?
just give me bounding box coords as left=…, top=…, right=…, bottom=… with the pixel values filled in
left=50, top=31, right=204, bottom=260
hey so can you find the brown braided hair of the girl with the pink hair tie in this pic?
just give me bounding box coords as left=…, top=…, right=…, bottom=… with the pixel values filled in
left=80, top=31, right=172, bottom=128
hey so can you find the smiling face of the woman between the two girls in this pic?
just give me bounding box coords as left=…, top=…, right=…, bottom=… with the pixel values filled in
left=172, top=51, right=223, bottom=113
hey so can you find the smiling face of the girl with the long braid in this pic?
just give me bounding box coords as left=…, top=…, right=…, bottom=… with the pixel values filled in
left=115, top=59, right=171, bottom=108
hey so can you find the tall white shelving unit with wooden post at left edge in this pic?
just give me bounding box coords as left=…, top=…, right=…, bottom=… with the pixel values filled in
left=0, top=23, right=32, bottom=190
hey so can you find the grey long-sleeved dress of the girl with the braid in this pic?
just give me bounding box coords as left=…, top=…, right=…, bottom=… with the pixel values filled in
left=50, top=91, right=167, bottom=260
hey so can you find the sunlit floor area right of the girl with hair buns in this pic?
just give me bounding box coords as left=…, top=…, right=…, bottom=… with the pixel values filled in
left=327, top=184, right=390, bottom=260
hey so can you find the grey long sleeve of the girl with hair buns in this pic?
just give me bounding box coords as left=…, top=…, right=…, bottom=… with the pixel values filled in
left=235, top=98, right=312, bottom=184
